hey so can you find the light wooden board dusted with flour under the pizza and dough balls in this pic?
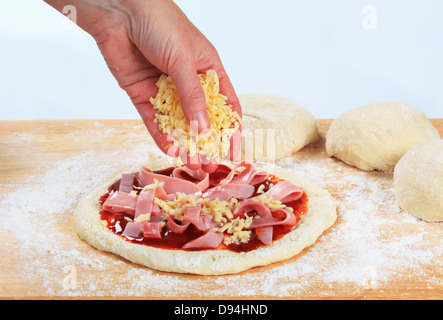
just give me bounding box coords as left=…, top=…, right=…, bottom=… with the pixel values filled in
left=0, top=119, right=443, bottom=299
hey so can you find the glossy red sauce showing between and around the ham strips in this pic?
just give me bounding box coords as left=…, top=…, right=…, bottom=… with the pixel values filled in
left=99, top=165, right=308, bottom=252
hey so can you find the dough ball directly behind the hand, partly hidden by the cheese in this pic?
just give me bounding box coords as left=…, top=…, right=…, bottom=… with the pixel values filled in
left=239, top=94, right=318, bottom=162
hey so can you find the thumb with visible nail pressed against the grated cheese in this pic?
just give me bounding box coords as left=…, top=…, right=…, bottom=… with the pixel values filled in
left=170, top=64, right=211, bottom=133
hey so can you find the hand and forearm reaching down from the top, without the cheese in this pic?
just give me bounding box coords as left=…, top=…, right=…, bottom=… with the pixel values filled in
left=45, top=0, right=242, bottom=172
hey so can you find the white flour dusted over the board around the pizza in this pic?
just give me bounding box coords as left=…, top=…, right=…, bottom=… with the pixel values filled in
left=0, top=145, right=443, bottom=297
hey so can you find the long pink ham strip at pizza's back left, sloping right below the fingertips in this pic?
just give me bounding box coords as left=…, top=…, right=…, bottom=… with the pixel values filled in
left=138, top=167, right=202, bottom=196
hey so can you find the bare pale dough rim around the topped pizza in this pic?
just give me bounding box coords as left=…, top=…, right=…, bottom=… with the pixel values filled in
left=74, top=157, right=337, bottom=275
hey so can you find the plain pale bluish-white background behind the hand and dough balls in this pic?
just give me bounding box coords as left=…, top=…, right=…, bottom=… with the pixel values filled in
left=0, top=0, right=443, bottom=120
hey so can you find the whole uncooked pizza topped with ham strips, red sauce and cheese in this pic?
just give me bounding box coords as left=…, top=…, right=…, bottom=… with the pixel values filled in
left=75, top=157, right=337, bottom=275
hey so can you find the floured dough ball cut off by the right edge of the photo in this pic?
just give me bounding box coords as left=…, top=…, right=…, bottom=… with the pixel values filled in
left=394, top=140, right=443, bottom=221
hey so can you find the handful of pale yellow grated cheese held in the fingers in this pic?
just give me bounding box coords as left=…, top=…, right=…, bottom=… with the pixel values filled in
left=150, top=70, right=241, bottom=161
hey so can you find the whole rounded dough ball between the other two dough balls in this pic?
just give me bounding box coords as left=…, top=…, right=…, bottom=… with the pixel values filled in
left=326, top=101, right=440, bottom=172
